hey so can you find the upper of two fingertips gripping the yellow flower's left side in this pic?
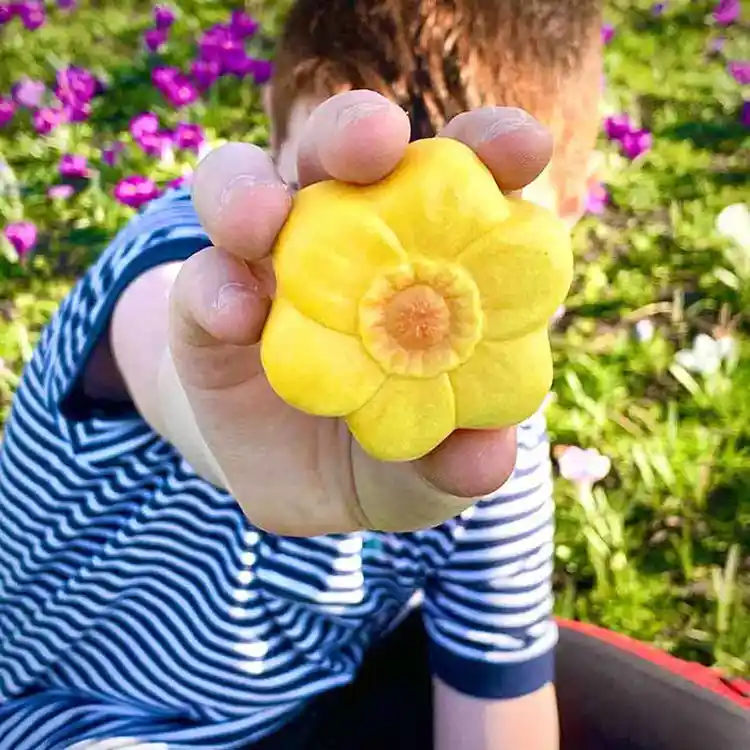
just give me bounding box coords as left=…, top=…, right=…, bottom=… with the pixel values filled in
left=193, top=143, right=292, bottom=260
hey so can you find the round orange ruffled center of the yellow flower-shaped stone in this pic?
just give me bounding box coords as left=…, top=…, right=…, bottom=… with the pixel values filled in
left=359, top=260, right=484, bottom=378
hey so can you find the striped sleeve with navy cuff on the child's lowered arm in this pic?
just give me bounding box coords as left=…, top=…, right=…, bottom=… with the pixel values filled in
left=424, top=414, right=557, bottom=699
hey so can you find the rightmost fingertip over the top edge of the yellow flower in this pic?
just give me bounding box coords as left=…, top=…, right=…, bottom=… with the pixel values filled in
left=440, top=107, right=553, bottom=197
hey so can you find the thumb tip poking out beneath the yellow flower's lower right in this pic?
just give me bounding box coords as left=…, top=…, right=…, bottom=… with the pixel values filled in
left=415, top=428, right=516, bottom=497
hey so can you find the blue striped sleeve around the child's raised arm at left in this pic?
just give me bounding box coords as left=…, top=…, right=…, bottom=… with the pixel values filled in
left=40, top=189, right=210, bottom=421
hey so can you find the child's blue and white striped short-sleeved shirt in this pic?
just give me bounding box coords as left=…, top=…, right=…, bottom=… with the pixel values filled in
left=0, top=191, right=557, bottom=750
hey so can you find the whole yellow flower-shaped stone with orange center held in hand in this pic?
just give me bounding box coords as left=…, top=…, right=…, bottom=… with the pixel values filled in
left=261, top=138, right=573, bottom=461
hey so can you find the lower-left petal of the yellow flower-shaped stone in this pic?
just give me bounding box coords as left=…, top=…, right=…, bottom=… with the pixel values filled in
left=260, top=297, right=385, bottom=417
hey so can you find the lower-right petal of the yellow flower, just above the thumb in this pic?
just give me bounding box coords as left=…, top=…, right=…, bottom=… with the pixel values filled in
left=450, top=327, right=552, bottom=429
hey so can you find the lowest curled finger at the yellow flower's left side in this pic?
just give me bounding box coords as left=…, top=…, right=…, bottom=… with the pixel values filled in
left=169, top=247, right=273, bottom=390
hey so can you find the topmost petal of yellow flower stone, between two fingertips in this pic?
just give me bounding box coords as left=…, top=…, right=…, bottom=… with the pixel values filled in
left=365, top=138, right=509, bottom=259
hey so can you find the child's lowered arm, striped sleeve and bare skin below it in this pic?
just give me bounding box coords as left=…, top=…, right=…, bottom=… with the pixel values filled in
left=423, top=414, right=557, bottom=750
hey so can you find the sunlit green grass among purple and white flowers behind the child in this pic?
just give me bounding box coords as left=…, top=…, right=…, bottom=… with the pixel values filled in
left=0, top=0, right=750, bottom=673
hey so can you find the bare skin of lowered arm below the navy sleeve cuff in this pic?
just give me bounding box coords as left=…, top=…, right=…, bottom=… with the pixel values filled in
left=434, top=679, right=559, bottom=750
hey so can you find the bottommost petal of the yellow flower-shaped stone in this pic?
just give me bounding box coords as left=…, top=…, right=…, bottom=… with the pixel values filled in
left=346, top=375, right=456, bottom=461
